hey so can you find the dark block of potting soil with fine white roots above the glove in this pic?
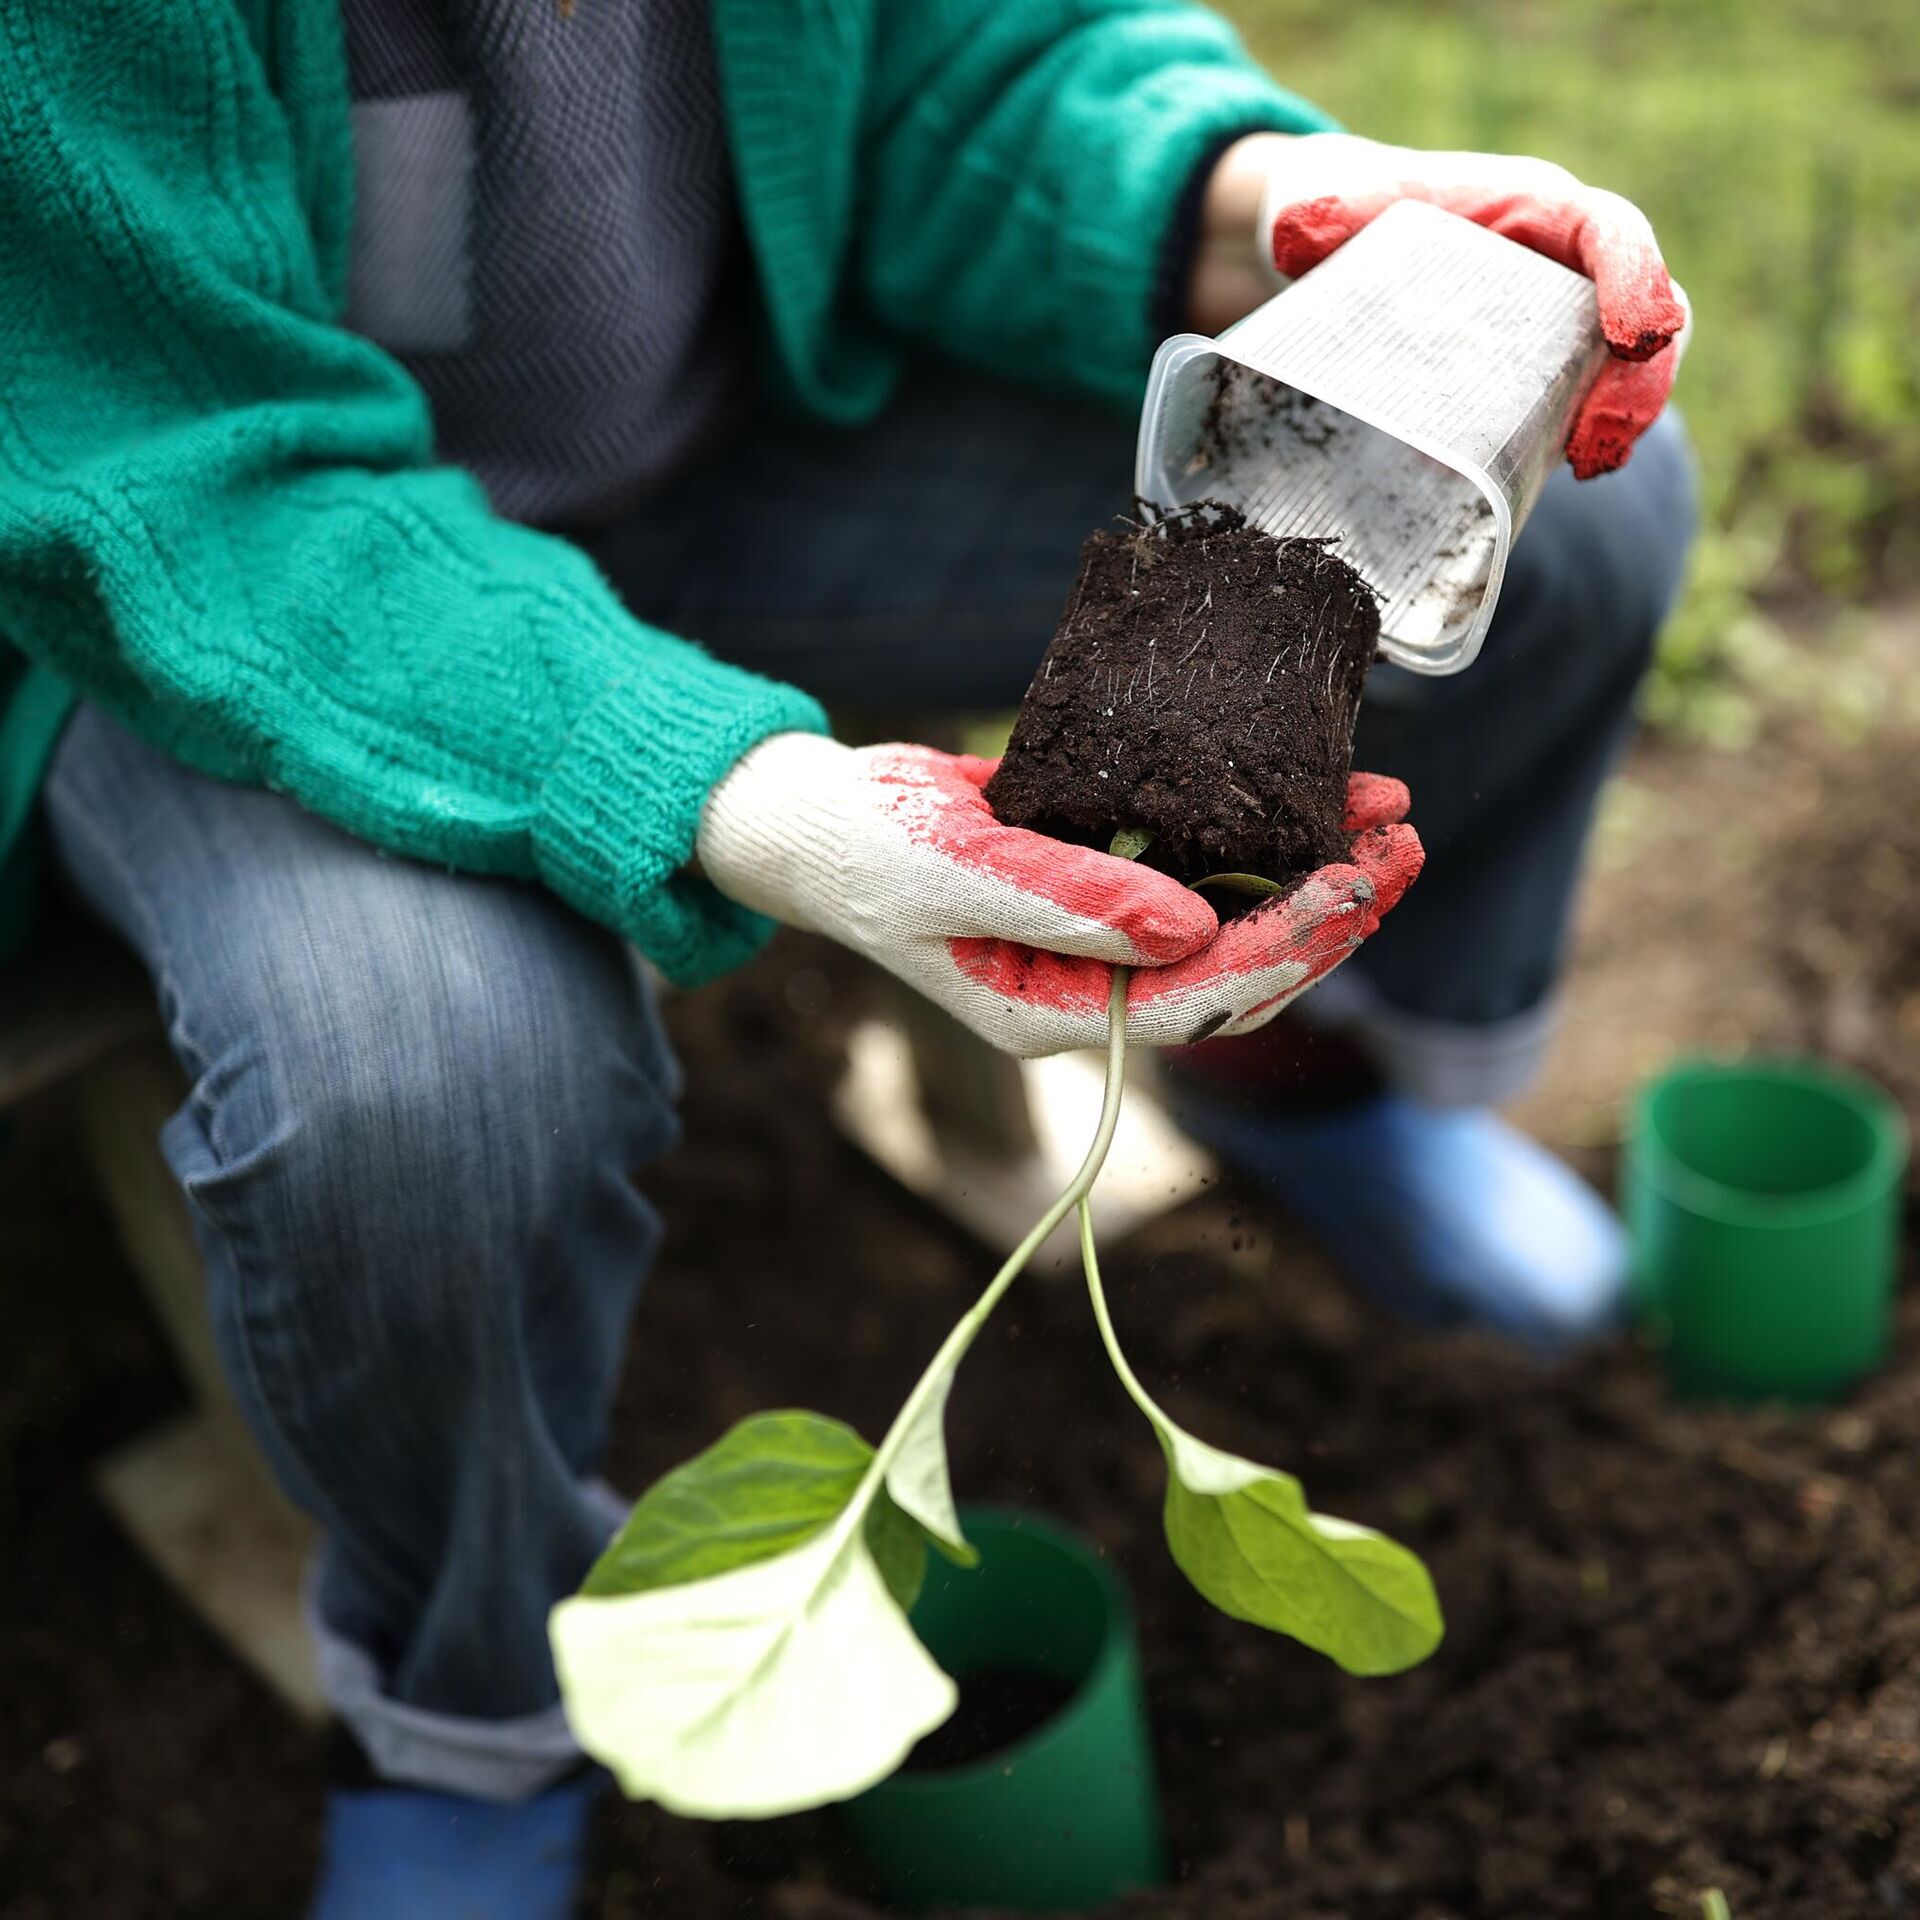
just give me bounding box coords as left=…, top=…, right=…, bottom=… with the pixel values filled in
left=987, top=505, right=1380, bottom=881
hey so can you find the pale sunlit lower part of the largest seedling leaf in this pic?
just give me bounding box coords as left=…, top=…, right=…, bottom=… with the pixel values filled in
left=551, top=1505, right=956, bottom=1820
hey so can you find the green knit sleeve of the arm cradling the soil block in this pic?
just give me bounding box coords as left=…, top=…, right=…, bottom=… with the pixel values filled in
left=0, top=0, right=824, bottom=981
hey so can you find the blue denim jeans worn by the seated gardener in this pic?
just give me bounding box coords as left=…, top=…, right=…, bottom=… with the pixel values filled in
left=46, top=374, right=1690, bottom=1797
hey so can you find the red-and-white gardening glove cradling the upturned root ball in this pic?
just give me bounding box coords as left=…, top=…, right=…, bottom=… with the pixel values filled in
left=697, top=733, right=1421, bottom=1056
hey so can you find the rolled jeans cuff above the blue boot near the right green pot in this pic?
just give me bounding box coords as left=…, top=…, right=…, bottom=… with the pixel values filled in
left=1294, top=968, right=1559, bottom=1106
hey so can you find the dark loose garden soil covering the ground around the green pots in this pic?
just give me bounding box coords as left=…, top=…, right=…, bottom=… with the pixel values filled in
left=0, top=879, right=1920, bottom=1920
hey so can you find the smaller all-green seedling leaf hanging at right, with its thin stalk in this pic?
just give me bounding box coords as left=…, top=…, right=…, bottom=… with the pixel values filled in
left=1079, top=1202, right=1444, bottom=1674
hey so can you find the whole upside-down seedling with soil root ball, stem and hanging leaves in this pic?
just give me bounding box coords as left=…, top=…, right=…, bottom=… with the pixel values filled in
left=551, top=509, right=1442, bottom=1818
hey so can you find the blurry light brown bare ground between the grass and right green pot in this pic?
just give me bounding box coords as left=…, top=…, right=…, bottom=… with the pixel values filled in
left=1523, top=691, right=1920, bottom=1146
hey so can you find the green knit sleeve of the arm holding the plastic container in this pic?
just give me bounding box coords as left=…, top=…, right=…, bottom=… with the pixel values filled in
left=856, top=0, right=1334, bottom=403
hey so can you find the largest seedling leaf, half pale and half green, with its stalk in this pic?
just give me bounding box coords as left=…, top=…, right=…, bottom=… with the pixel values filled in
left=549, top=1336, right=1004, bottom=1820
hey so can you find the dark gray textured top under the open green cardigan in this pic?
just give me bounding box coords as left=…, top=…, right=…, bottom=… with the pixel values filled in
left=342, top=0, right=751, bottom=528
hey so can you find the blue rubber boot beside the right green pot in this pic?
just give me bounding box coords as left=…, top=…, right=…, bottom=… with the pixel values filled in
left=1165, top=1073, right=1628, bottom=1357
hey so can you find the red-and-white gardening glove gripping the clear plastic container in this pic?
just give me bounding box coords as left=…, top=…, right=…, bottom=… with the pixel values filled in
left=1254, top=132, right=1692, bottom=480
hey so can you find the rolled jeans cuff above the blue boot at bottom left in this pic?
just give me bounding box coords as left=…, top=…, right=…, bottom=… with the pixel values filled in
left=305, top=1480, right=628, bottom=1801
